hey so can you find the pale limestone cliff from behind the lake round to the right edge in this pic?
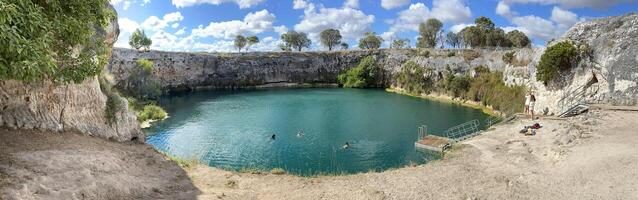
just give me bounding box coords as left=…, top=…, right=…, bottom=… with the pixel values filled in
left=108, top=13, right=638, bottom=115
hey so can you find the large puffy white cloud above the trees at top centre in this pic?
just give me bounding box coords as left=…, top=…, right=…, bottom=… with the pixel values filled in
left=294, top=0, right=374, bottom=41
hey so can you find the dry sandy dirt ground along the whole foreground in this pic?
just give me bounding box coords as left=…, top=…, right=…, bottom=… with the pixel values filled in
left=0, top=110, right=638, bottom=199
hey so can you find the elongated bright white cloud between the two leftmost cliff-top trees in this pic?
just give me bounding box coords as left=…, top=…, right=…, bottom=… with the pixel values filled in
left=192, top=9, right=275, bottom=39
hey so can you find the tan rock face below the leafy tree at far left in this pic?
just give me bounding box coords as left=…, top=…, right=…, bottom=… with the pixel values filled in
left=0, top=7, right=144, bottom=141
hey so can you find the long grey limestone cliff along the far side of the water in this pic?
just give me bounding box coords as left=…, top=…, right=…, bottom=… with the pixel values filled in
left=108, top=48, right=532, bottom=91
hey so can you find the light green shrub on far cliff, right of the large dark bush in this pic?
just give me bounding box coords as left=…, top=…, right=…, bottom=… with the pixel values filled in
left=394, top=61, right=434, bottom=94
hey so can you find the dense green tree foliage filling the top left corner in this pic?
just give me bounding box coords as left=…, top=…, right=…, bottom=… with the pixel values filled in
left=0, top=0, right=114, bottom=83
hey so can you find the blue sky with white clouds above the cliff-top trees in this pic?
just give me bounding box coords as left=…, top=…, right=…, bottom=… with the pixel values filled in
left=111, top=0, right=638, bottom=52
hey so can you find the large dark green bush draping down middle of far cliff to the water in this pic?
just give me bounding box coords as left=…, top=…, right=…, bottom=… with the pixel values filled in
left=338, top=56, right=377, bottom=88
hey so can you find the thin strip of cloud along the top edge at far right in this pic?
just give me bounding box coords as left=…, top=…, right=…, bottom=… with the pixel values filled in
left=505, top=0, right=635, bottom=9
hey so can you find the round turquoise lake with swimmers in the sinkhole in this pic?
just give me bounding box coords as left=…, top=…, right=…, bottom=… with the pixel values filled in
left=145, top=88, right=488, bottom=175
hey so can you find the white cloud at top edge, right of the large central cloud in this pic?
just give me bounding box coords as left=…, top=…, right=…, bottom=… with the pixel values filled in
left=390, top=0, right=472, bottom=32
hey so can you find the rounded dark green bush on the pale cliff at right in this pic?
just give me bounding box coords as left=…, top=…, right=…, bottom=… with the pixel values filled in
left=536, top=41, right=578, bottom=84
